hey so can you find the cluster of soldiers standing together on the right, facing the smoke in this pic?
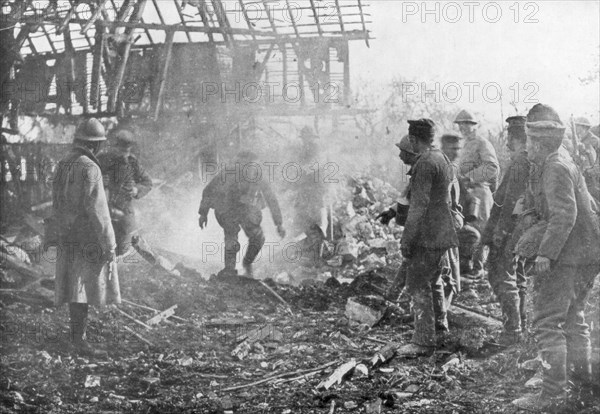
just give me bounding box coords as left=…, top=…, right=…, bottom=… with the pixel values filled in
left=379, top=104, right=600, bottom=409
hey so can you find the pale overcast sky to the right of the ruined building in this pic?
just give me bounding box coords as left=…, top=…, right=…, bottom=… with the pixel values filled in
left=351, top=0, right=600, bottom=123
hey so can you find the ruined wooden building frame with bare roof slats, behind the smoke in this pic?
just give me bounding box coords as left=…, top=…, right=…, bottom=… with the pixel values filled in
left=0, top=0, right=371, bottom=217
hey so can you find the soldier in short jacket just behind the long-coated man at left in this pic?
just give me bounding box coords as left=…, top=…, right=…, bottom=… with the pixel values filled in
left=98, top=130, right=152, bottom=256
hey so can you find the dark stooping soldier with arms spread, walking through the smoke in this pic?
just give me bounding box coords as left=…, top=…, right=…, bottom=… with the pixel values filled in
left=198, top=151, right=285, bottom=276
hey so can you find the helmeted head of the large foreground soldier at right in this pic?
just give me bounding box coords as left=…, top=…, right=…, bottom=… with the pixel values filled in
left=525, top=104, right=565, bottom=163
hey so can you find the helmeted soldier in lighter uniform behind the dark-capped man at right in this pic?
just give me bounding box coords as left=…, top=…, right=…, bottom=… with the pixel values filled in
left=454, top=110, right=499, bottom=277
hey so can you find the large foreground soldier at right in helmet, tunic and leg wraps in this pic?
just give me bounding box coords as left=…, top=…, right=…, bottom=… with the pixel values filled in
left=513, top=104, right=600, bottom=410
